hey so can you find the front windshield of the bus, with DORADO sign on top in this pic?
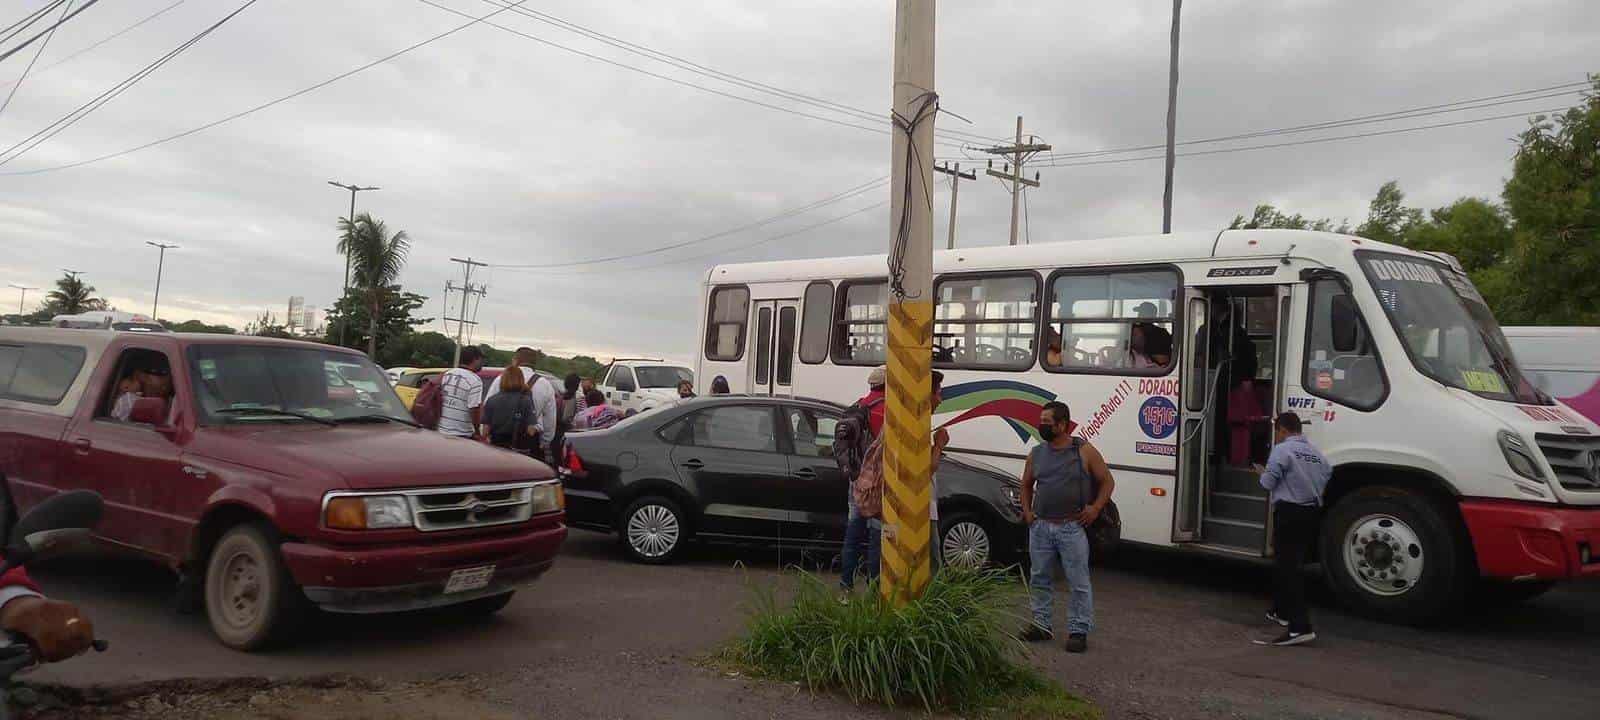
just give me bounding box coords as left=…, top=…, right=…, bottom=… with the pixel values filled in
left=1360, top=253, right=1550, bottom=405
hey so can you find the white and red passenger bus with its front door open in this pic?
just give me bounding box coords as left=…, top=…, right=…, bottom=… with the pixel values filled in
left=696, top=230, right=1600, bottom=621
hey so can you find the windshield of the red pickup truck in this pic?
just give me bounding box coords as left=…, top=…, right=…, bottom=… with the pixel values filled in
left=189, top=344, right=411, bottom=424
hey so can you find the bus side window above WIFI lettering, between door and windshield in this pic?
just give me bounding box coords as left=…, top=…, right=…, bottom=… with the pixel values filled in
left=1301, top=280, right=1389, bottom=410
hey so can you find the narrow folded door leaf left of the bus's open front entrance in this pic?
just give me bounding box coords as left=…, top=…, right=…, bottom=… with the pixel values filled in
left=1173, top=288, right=1214, bottom=542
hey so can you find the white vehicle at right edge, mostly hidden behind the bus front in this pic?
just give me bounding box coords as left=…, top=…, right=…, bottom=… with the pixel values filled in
left=1501, top=326, right=1600, bottom=422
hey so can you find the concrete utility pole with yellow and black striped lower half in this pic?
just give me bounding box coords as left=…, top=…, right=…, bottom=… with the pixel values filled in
left=878, top=0, right=938, bottom=605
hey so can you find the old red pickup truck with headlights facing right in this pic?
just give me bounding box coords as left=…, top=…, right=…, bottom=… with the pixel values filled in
left=0, top=328, right=566, bottom=650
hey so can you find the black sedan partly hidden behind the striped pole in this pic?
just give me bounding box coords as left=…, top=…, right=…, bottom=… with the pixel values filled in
left=565, top=395, right=1024, bottom=565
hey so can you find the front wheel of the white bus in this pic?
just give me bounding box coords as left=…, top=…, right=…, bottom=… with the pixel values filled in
left=1322, top=486, right=1472, bottom=624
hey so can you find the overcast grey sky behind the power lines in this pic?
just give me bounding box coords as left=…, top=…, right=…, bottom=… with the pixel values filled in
left=0, top=0, right=1600, bottom=358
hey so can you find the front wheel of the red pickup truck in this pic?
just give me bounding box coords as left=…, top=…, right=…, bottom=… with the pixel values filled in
left=205, top=525, right=304, bottom=650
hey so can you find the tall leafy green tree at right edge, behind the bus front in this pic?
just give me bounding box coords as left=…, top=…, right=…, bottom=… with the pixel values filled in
left=1496, top=75, right=1600, bottom=325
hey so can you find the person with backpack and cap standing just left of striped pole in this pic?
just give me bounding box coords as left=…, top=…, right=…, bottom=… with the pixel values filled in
left=834, top=366, right=888, bottom=592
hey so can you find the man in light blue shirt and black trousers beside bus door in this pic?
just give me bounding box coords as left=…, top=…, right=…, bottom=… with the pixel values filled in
left=1256, top=413, right=1333, bottom=646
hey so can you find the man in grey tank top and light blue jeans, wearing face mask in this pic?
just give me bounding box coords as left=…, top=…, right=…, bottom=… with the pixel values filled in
left=1021, top=402, right=1117, bottom=653
